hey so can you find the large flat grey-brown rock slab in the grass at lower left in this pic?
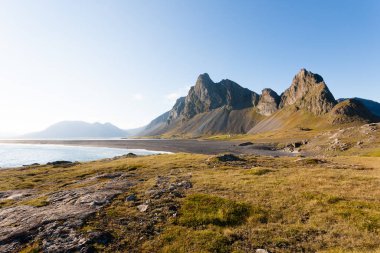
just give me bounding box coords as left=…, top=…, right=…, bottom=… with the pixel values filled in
left=0, top=172, right=134, bottom=252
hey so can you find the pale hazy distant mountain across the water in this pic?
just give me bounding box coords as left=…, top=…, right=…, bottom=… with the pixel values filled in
left=22, top=121, right=129, bottom=139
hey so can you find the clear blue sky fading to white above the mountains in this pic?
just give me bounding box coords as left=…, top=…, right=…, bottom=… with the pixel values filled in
left=0, top=0, right=380, bottom=134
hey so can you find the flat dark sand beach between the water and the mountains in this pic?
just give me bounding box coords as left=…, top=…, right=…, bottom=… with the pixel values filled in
left=0, top=139, right=294, bottom=156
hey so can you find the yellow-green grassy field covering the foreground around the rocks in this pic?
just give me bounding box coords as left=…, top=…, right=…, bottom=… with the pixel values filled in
left=0, top=154, right=380, bottom=253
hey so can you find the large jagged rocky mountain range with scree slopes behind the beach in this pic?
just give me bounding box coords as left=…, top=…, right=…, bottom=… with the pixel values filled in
left=139, top=69, right=380, bottom=136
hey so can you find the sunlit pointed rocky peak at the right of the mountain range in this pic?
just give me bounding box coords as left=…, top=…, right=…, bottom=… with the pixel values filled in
left=280, top=69, right=337, bottom=115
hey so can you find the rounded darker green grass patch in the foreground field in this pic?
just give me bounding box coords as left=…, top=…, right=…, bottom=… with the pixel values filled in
left=178, top=194, right=251, bottom=227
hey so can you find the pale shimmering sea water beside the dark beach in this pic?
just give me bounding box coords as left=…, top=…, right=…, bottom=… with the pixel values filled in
left=0, top=144, right=167, bottom=168
